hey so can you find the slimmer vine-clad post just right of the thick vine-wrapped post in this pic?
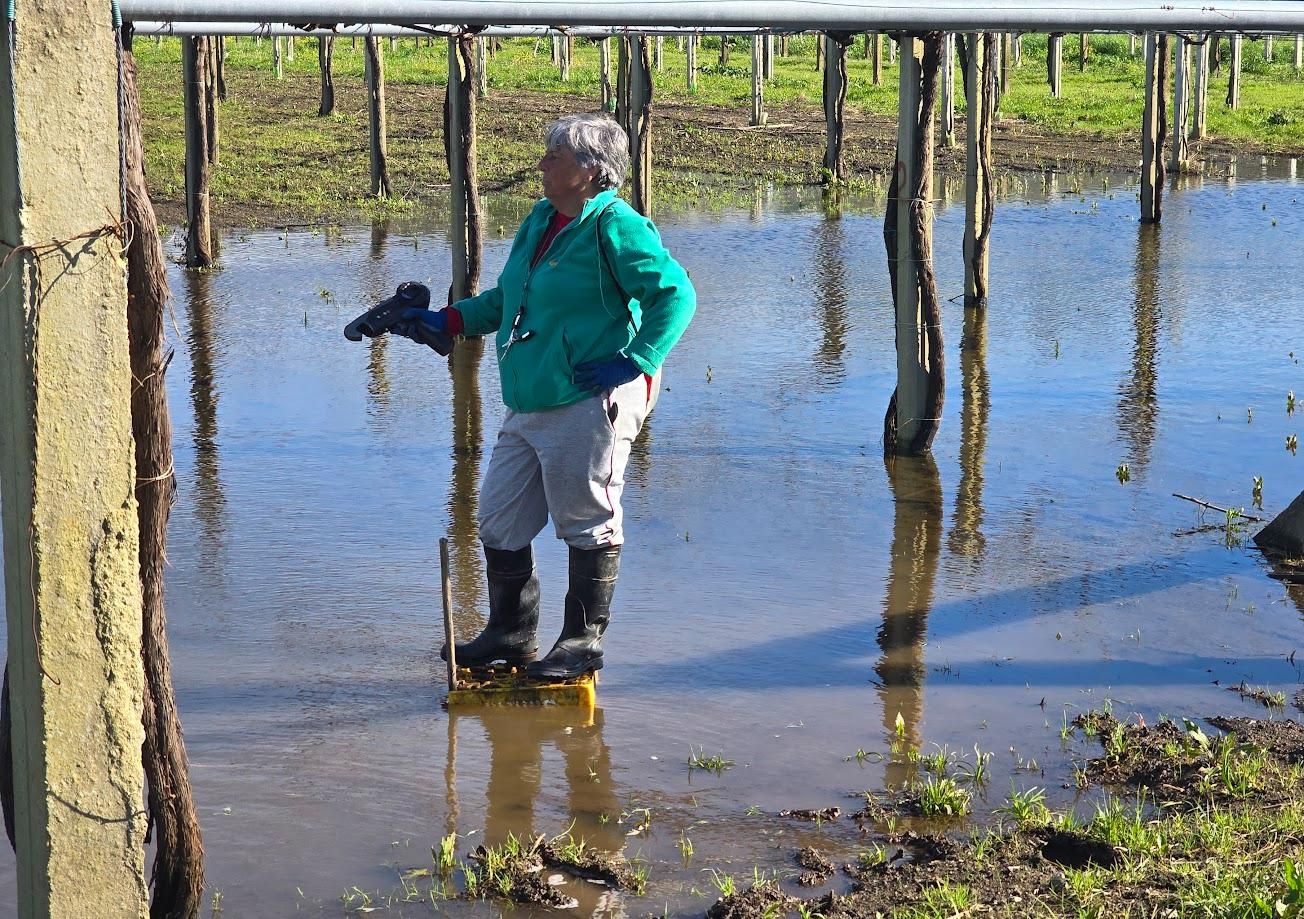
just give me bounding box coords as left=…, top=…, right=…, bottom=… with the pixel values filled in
left=964, top=33, right=998, bottom=308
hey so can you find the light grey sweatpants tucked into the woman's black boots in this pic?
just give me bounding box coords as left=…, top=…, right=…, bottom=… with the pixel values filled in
left=480, top=374, right=661, bottom=550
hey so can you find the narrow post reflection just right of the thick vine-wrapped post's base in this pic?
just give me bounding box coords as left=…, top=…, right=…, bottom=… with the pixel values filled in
left=947, top=308, right=991, bottom=561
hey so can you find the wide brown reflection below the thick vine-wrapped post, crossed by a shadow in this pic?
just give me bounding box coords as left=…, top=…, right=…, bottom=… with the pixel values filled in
left=874, top=455, right=943, bottom=789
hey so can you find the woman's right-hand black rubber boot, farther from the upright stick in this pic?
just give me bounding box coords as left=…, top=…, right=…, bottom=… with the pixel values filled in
left=527, top=546, right=621, bottom=679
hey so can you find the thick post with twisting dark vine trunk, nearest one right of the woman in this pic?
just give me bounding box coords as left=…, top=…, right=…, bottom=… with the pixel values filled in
left=883, top=34, right=945, bottom=454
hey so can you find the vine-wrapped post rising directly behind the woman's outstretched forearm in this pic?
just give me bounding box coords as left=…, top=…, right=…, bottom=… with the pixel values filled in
left=443, top=34, right=484, bottom=302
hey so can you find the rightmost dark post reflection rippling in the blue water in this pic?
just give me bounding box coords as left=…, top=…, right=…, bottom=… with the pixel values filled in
left=1119, top=223, right=1161, bottom=472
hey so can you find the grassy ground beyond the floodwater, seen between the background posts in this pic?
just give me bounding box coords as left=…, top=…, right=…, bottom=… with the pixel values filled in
left=136, top=35, right=1304, bottom=222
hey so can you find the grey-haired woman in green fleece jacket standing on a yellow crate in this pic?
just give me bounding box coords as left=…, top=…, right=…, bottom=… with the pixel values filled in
left=396, top=115, right=696, bottom=678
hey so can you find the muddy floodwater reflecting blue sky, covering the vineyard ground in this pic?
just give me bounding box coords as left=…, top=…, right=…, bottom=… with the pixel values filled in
left=0, top=160, right=1304, bottom=916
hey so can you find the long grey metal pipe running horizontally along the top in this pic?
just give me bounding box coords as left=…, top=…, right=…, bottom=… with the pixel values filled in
left=120, top=0, right=1304, bottom=31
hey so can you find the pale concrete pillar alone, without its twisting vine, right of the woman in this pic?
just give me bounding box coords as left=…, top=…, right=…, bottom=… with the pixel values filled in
left=895, top=34, right=928, bottom=446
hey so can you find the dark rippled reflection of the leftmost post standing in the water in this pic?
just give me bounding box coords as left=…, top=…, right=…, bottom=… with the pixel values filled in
left=184, top=270, right=227, bottom=571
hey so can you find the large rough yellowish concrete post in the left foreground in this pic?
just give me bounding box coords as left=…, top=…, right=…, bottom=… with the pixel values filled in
left=0, top=0, right=149, bottom=919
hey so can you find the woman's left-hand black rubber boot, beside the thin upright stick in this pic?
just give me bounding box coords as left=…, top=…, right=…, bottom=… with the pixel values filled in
left=439, top=546, right=539, bottom=667
